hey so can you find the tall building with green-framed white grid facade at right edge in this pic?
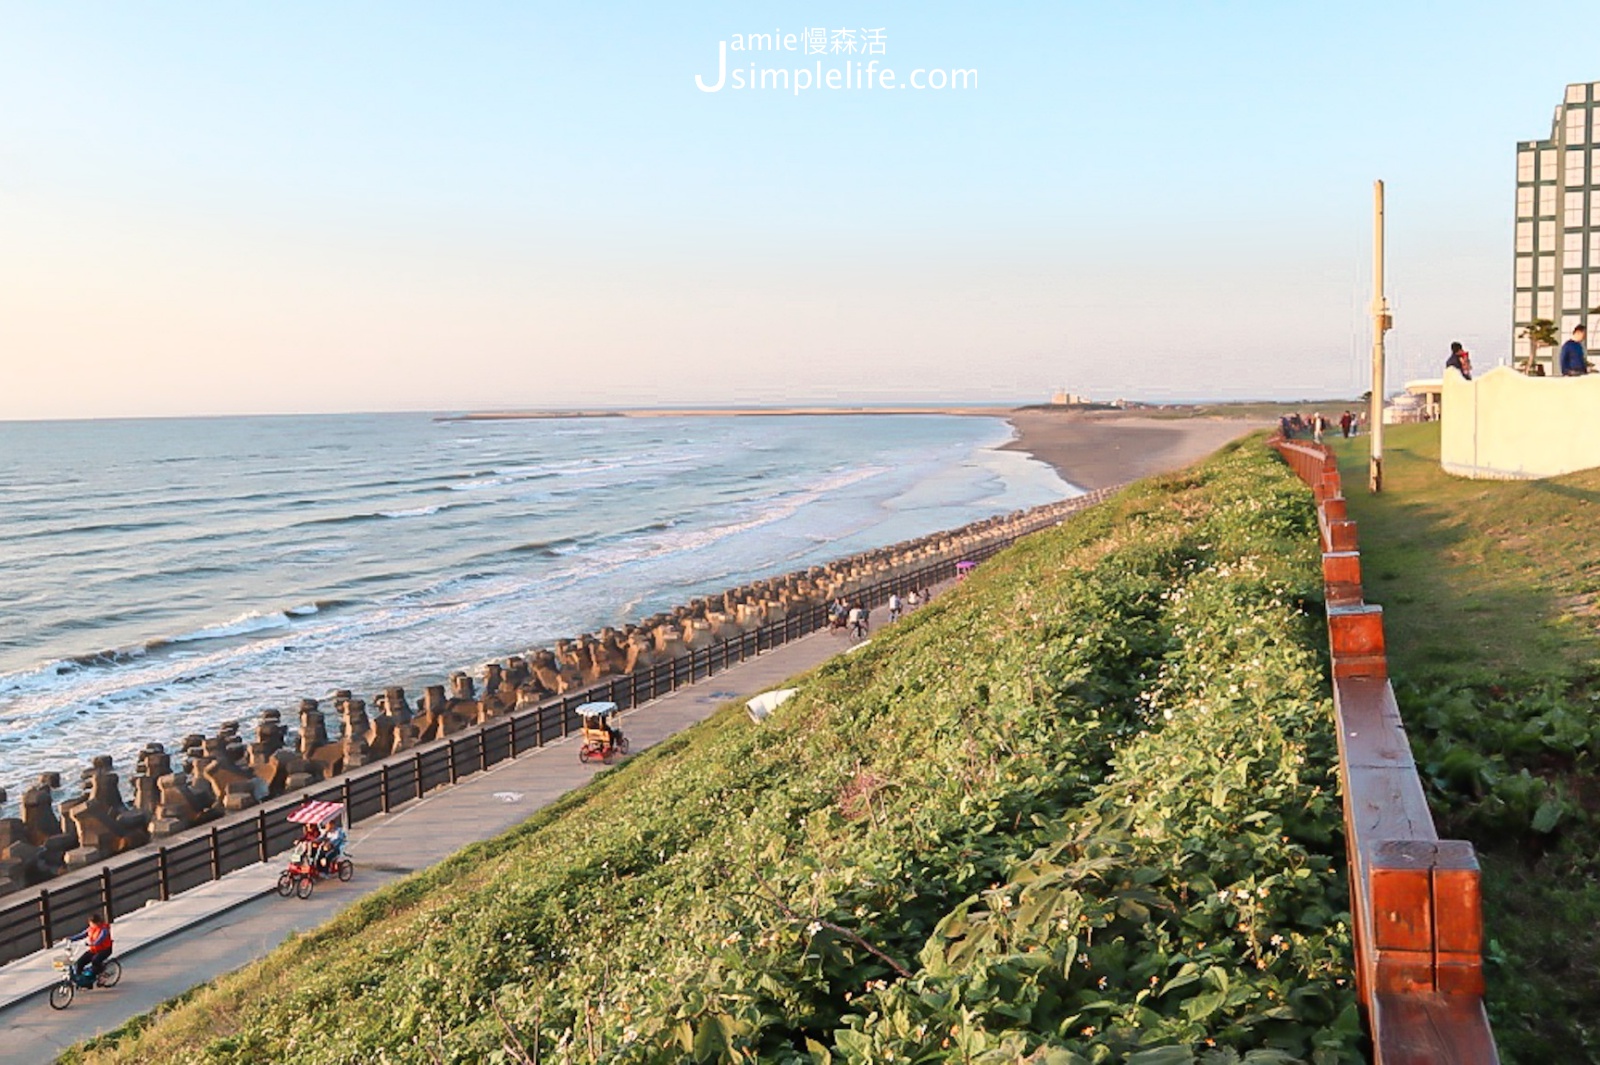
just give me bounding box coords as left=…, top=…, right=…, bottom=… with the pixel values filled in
left=1512, top=82, right=1600, bottom=366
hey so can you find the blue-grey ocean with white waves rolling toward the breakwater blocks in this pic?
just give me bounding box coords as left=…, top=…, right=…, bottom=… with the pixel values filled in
left=0, top=414, right=1077, bottom=799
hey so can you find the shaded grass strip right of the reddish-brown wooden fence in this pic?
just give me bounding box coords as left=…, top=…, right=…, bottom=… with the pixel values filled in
left=1338, top=425, right=1600, bottom=1065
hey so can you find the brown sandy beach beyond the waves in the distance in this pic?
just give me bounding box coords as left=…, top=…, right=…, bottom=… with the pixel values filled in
left=1005, top=409, right=1270, bottom=491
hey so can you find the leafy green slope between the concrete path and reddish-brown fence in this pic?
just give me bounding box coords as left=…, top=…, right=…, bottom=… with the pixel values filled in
left=72, top=438, right=1360, bottom=1065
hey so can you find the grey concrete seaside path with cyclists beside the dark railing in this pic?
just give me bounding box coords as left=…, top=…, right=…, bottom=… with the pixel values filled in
left=0, top=608, right=888, bottom=1063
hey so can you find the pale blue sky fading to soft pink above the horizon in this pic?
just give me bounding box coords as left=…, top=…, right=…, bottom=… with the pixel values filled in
left=0, top=0, right=1600, bottom=419
